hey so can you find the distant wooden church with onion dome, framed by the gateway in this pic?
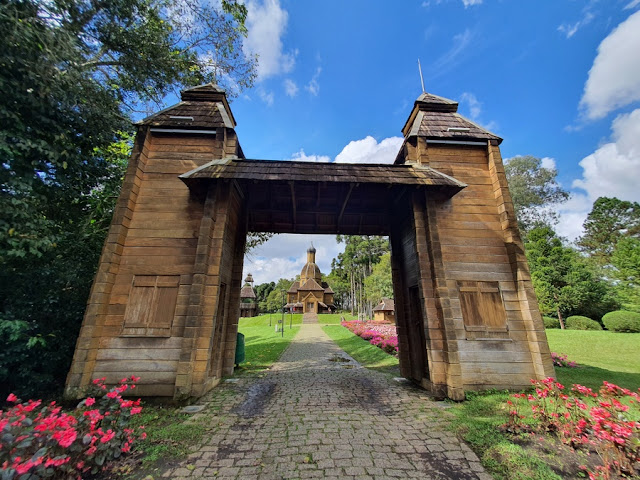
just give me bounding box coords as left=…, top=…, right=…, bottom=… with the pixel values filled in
left=284, top=245, right=335, bottom=313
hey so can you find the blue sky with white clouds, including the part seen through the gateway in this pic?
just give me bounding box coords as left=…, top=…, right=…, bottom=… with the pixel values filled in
left=219, top=0, right=640, bottom=283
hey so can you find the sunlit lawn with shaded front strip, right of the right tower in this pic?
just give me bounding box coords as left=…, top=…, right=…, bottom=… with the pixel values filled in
left=546, top=329, right=640, bottom=390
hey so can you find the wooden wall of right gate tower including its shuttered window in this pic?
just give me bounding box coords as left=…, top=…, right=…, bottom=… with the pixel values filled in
left=405, top=137, right=554, bottom=390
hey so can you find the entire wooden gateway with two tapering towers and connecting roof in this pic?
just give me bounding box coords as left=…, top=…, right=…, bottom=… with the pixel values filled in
left=67, top=85, right=554, bottom=399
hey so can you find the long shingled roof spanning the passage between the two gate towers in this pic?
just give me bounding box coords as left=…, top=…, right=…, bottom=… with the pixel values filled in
left=180, top=158, right=466, bottom=190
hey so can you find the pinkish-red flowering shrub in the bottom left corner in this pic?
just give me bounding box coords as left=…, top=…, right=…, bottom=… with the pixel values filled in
left=0, top=376, right=146, bottom=480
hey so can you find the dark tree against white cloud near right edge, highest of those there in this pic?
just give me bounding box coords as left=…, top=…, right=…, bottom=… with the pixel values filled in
left=578, top=197, right=640, bottom=267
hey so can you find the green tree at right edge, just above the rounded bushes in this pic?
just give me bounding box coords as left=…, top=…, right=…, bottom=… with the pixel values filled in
left=611, top=237, right=640, bottom=305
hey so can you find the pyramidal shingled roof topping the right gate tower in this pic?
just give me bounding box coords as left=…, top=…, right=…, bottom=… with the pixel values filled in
left=402, top=93, right=502, bottom=144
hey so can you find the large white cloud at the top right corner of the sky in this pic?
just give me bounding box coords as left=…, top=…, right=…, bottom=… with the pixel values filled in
left=580, top=12, right=640, bottom=120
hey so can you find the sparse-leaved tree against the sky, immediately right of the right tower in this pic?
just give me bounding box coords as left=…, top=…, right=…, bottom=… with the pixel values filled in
left=504, top=156, right=569, bottom=236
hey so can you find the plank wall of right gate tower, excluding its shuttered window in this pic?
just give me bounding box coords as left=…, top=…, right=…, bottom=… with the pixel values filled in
left=412, top=139, right=553, bottom=389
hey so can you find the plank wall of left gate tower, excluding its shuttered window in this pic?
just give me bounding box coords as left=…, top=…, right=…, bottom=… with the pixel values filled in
left=68, top=129, right=231, bottom=396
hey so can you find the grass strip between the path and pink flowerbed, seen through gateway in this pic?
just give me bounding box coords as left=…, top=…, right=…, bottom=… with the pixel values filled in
left=323, top=325, right=399, bottom=375
